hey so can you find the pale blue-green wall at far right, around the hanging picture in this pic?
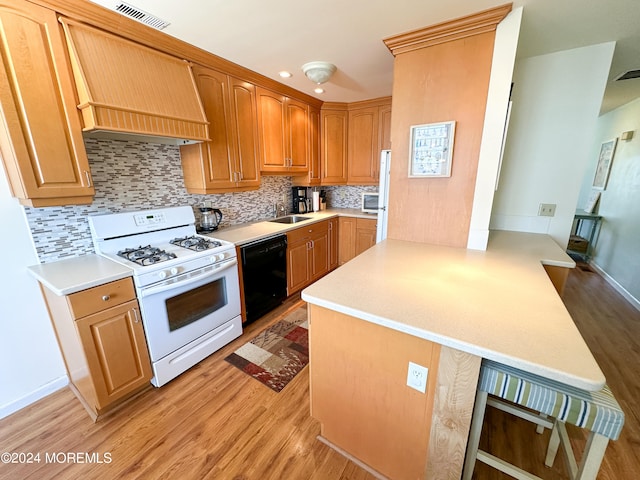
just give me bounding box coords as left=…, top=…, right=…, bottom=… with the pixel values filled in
left=578, top=99, right=640, bottom=305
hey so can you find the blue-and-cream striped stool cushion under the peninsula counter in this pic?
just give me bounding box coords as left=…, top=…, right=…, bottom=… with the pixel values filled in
left=478, top=359, right=624, bottom=440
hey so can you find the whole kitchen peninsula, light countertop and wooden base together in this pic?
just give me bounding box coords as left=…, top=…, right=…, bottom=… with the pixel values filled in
left=302, top=231, right=605, bottom=478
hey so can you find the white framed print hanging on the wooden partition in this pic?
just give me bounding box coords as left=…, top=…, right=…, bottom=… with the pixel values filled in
left=409, top=121, right=456, bottom=178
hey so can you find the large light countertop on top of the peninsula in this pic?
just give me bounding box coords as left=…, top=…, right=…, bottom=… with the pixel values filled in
left=302, top=231, right=605, bottom=390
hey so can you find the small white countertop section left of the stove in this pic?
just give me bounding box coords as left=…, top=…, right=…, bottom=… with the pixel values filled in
left=28, top=254, right=133, bottom=295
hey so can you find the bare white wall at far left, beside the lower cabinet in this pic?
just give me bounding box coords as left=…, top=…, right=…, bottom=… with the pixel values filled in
left=0, top=168, right=67, bottom=418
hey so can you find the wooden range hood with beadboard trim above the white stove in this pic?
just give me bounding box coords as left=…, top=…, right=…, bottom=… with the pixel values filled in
left=60, top=17, right=209, bottom=145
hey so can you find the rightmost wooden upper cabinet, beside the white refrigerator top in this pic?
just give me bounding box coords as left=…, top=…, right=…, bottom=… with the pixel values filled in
left=347, top=100, right=391, bottom=185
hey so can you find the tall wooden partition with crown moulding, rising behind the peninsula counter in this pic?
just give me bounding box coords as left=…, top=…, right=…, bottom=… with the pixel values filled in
left=384, top=4, right=511, bottom=247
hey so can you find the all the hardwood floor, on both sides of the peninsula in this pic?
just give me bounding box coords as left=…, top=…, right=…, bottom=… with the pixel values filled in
left=0, top=269, right=640, bottom=480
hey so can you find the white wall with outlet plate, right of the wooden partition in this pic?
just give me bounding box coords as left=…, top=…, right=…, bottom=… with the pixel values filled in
left=491, top=42, right=615, bottom=246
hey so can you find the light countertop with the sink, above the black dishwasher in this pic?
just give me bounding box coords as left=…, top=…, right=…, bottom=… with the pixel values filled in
left=207, top=208, right=377, bottom=245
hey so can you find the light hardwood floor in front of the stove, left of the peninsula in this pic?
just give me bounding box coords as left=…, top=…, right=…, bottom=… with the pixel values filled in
left=0, top=297, right=374, bottom=480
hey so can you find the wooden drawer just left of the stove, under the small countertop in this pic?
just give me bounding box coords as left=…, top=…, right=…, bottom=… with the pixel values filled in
left=67, top=278, right=136, bottom=319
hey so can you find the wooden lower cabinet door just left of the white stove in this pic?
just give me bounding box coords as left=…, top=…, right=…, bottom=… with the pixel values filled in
left=76, top=300, right=152, bottom=410
